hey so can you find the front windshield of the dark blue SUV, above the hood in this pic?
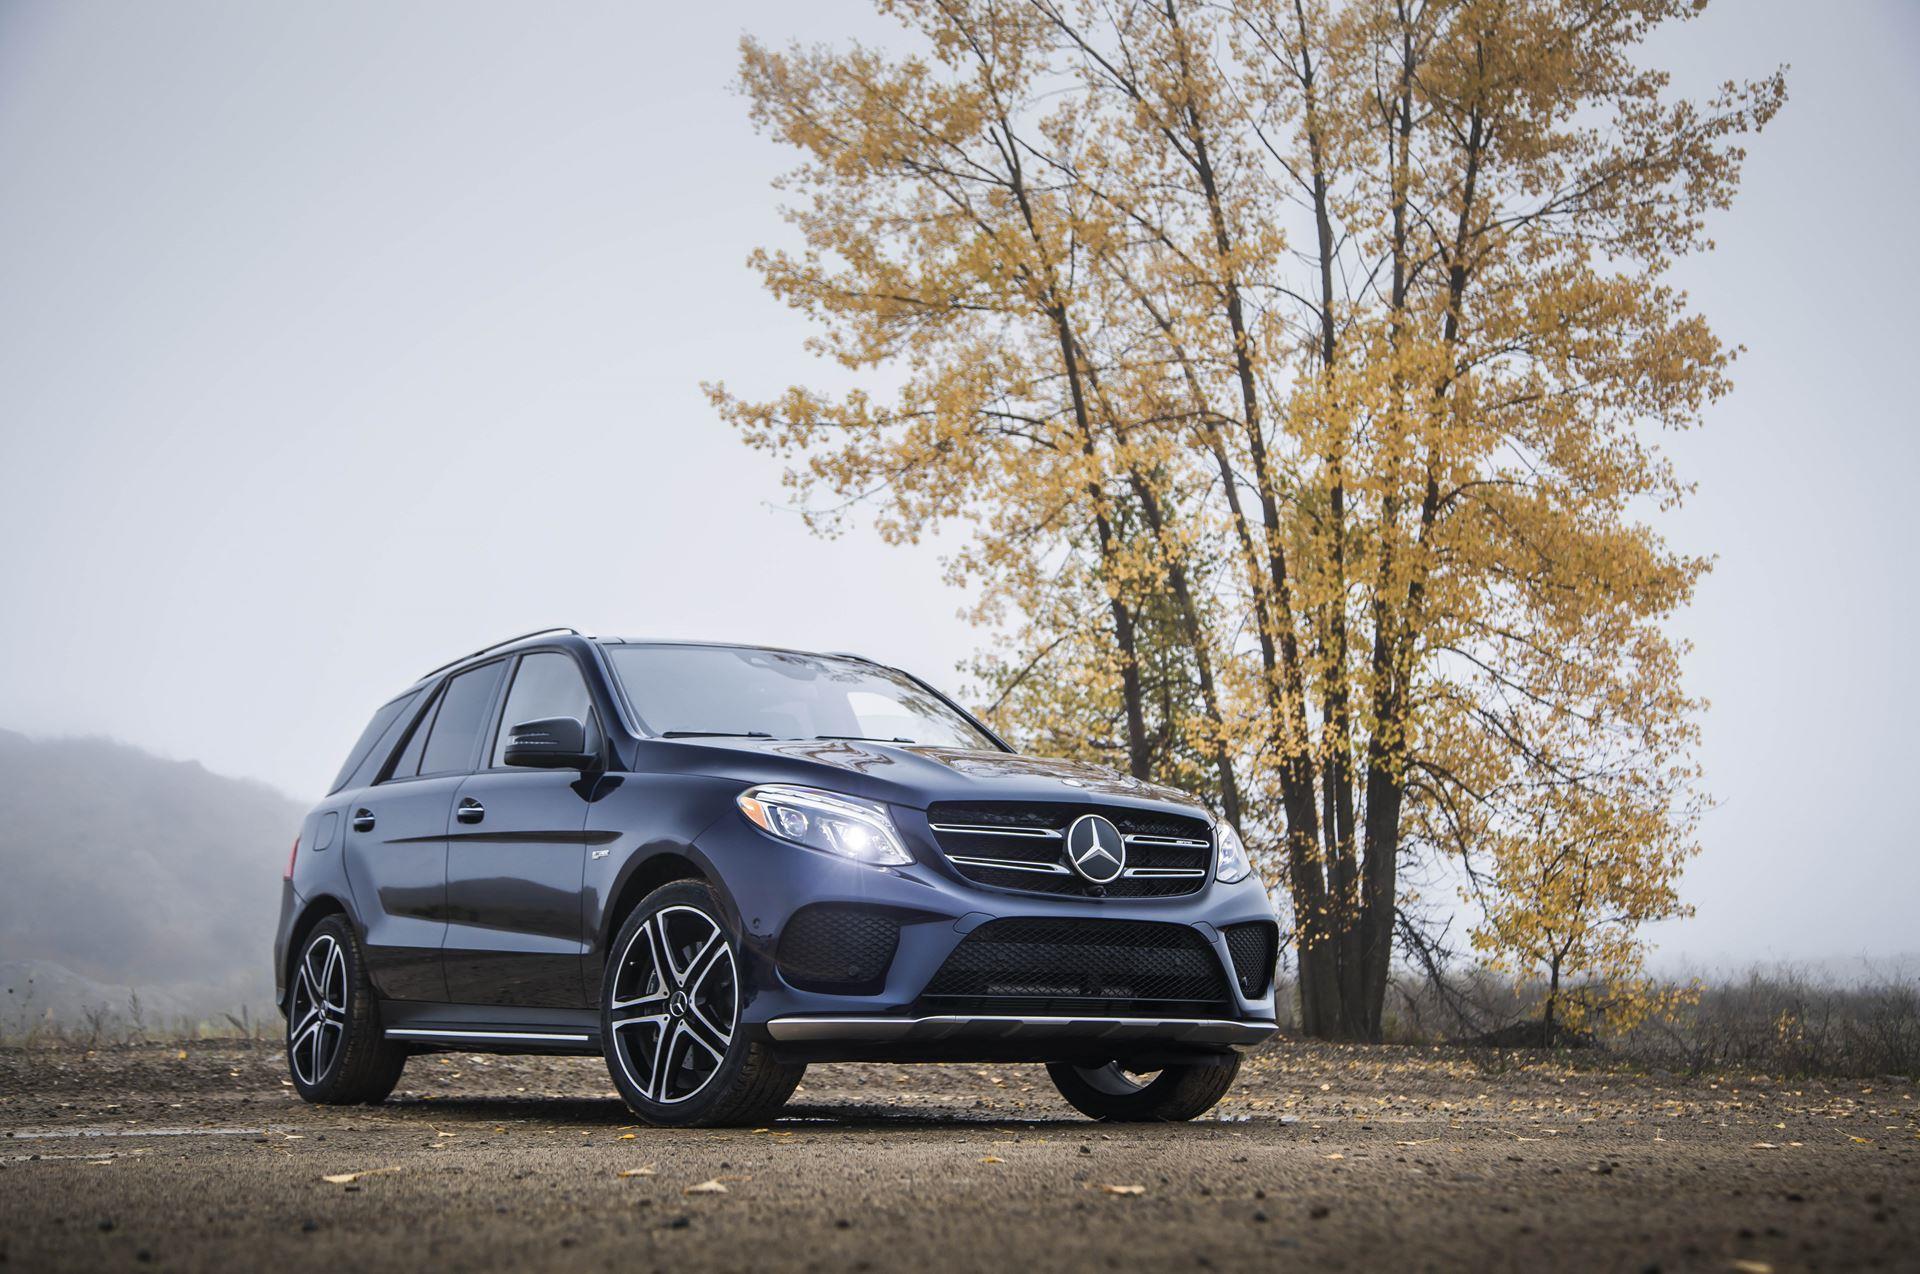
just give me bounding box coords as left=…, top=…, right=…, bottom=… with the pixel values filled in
left=607, top=647, right=996, bottom=750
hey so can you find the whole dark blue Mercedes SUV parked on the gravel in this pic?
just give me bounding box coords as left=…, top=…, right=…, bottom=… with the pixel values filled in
left=275, top=629, right=1279, bottom=1124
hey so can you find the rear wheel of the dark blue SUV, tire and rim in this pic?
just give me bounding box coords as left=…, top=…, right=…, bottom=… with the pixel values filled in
left=286, top=915, right=407, bottom=1105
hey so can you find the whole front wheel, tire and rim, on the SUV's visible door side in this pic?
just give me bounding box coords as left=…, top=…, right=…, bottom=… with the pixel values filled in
left=601, top=881, right=806, bottom=1128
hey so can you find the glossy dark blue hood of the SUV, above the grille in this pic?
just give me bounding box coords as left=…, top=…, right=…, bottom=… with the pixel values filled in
left=652, top=739, right=1208, bottom=817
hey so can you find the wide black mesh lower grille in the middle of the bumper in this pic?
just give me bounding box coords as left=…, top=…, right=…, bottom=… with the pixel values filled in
left=924, top=917, right=1229, bottom=1015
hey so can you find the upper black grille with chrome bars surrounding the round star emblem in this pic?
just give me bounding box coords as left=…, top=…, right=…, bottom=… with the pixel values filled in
left=927, top=800, right=1213, bottom=898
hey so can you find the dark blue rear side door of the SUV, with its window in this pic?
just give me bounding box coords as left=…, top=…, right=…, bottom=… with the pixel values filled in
left=346, top=660, right=507, bottom=1002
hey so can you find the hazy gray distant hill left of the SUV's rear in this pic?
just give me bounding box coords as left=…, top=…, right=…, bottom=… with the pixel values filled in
left=0, top=731, right=303, bottom=1025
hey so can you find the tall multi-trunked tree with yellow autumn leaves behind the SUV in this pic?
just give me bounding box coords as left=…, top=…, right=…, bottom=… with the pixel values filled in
left=712, top=0, right=1784, bottom=1038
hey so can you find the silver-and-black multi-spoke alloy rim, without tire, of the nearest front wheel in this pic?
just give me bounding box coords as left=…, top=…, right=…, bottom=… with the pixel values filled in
left=607, top=904, right=739, bottom=1105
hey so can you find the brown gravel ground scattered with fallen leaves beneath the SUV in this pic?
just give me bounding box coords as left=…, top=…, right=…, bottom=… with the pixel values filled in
left=0, top=1044, right=1920, bottom=1274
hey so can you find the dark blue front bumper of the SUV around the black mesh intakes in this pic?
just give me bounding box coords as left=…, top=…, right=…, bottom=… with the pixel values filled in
left=697, top=812, right=1275, bottom=1061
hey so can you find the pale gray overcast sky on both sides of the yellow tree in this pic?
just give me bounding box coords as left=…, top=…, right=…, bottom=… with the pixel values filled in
left=0, top=0, right=1920, bottom=963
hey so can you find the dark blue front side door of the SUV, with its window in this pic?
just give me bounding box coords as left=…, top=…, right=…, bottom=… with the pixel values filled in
left=445, top=650, right=599, bottom=1007
